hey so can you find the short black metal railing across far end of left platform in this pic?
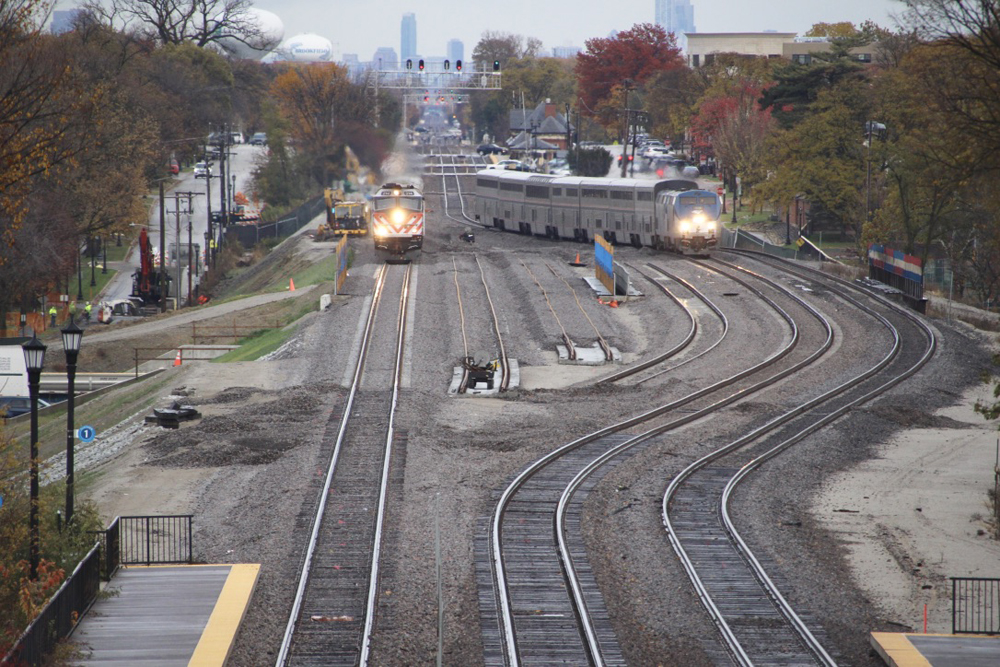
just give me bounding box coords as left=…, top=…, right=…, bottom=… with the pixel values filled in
left=118, top=514, right=194, bottom=565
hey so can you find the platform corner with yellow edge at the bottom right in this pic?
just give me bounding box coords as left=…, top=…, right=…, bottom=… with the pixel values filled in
left=871, top=632, right=1000, bottom=667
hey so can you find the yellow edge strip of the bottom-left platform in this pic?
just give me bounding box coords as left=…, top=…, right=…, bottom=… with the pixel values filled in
left=188, top=563, right=260, bottom=667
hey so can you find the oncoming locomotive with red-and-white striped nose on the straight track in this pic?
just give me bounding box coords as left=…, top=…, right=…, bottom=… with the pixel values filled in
left=371, top=183, right=424, bottom=258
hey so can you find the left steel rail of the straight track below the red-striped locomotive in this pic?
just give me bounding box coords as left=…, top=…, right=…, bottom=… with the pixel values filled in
left=275, top=264, right=388, bottom=667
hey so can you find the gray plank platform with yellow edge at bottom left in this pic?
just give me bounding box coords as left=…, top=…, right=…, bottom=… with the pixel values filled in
left=69, top=564, right=260, bottom=667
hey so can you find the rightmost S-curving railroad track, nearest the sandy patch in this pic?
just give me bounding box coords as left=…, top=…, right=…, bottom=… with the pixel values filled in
left=661, top=253, right=935, bottom=665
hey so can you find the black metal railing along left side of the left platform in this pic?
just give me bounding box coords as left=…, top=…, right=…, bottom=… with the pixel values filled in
left=0, top=544, right=101, bottom=665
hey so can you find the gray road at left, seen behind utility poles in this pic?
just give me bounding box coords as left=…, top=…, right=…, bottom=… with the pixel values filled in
left=101, top=144, right=267, bottom=303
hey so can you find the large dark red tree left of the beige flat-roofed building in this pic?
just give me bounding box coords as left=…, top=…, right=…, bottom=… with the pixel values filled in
left=575, top=23, right=684, bottom=127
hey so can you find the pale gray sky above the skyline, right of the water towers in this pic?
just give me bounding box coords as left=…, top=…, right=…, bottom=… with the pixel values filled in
left=246, top=0, right=904, bottom=61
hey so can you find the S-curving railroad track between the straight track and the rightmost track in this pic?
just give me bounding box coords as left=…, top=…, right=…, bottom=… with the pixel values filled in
left=477, top=258, right=832, bottom=665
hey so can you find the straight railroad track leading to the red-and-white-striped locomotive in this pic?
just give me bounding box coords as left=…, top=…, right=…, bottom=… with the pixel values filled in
left=276, top=264, right=410, bottom=667
